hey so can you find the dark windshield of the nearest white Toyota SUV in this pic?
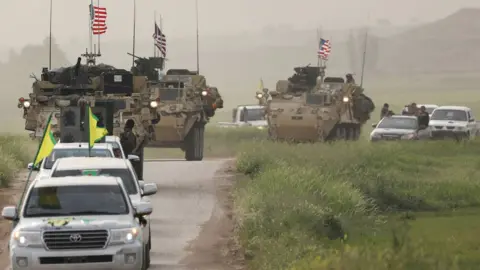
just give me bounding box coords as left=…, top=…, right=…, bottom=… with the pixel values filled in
left=24, top=185, right=129, bottom=217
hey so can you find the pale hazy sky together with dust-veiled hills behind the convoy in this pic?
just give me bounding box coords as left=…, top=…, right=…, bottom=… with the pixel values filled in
left=0, top=0, right=480, bottom=131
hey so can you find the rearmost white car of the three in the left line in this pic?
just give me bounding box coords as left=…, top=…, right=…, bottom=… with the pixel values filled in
left=27, top=142, right=114, bottom=179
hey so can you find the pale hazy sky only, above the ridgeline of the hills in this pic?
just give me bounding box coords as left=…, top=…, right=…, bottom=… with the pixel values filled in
left=0, top=0, right=480, bottom=48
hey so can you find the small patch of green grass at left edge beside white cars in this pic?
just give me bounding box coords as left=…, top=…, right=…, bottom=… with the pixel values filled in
left=0, top=135, right=35, bottom=187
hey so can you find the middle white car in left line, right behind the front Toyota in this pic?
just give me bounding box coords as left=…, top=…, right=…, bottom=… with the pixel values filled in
left=50, top=157, right=157, bottom=265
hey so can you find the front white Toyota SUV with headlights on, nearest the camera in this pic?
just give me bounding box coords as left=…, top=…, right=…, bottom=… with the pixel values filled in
left=2, top=176, right=152, bottom=270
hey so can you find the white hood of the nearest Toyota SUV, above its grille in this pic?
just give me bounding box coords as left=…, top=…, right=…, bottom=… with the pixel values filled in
left=17, top=215, right=134, bottom=231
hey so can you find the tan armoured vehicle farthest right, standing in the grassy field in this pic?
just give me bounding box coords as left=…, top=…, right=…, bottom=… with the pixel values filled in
left=267, top=66, right=375, bottom=141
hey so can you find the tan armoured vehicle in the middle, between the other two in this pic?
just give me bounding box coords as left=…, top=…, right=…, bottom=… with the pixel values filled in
left=149, top=69, right=223, bottom=161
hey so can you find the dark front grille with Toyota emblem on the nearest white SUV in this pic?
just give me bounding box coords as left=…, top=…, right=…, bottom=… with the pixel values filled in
left=43, top=230, right=108, bottom=250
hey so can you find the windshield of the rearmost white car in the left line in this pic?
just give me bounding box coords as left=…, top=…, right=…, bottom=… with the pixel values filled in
left=43, top=148, right=112, bottom=170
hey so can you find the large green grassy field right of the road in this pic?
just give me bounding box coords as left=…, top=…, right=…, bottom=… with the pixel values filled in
left=235, top=138, right=480, bottom=270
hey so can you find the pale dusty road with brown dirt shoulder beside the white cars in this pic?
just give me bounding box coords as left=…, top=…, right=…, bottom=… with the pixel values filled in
left=2, top=160, right=243, bottom=270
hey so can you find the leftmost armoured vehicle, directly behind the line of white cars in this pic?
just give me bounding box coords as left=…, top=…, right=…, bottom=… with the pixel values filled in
left=18, top=54, right=159, bottom=177
